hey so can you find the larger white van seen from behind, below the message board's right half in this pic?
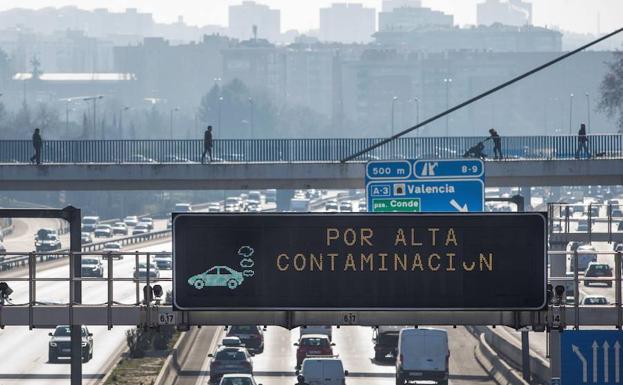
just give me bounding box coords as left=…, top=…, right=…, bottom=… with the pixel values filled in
left=396, top=328, right=450, bottom=385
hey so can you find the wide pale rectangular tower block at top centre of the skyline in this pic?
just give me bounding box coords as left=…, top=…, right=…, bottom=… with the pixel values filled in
left=319, top=3, right=376, bottom=43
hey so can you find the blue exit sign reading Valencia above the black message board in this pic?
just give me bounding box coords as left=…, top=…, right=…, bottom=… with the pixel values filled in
left=366, top=159, right=485, bottom=212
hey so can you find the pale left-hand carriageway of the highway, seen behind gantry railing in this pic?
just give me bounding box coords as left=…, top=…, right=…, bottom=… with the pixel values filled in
left=0, top=225, right=171, bottom=385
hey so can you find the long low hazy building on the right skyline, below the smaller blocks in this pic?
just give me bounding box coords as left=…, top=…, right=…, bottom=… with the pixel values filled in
left=374, top=24, right=562, bottom=52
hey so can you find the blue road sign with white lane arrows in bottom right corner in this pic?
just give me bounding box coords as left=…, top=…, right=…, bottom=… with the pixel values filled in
left=560, top=330, right=623, bottom=385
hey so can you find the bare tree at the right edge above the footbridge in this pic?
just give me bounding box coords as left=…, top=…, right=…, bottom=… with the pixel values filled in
left=597, top=51, right=623, bottom=132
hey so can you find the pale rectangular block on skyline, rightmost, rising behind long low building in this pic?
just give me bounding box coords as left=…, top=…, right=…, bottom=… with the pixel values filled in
left=477, top=0, right=532, bottom=27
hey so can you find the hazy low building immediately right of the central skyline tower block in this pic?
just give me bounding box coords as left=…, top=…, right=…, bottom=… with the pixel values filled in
left=379, top=7, right=454, bottom=31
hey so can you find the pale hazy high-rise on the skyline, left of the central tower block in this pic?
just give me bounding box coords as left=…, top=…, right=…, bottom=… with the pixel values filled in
left=229, top=1, right=281, bottom=42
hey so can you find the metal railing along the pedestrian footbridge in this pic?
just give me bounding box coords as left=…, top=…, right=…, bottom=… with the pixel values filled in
left=0, top=134, right=623, bottom=163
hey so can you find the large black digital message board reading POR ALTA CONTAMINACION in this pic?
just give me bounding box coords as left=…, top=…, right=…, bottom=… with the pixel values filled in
left=173, top=213, right=546, bottom=310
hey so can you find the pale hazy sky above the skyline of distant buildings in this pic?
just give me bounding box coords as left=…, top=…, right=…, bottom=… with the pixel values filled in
left=0, top=0, right=623, bottom=33
